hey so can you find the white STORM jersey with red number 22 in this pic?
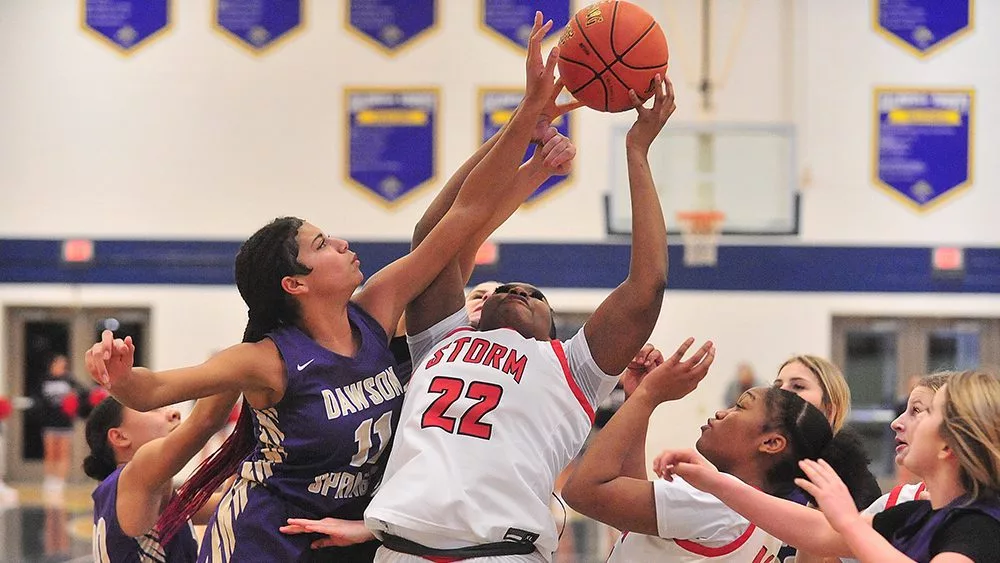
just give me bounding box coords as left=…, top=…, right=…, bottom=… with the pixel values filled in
left=365, top=328, right=594, bottom=560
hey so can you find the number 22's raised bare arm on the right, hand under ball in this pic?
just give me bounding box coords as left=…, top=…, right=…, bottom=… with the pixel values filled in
left=584, top=75, right=676, bottom=373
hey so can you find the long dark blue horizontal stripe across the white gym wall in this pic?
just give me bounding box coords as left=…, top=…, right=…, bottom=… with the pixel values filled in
left=0, top=239, right=1000, bottom=293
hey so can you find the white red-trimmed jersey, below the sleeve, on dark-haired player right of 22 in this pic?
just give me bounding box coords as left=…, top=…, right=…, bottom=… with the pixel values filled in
left=608, top=524, right=781, bottom=563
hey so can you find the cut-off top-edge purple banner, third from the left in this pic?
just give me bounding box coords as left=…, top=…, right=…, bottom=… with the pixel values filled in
left=347, top=0, right=437, bottom=55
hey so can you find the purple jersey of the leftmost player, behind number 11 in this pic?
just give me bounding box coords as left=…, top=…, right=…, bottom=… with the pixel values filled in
left=92, top=465, right=198, bottom=563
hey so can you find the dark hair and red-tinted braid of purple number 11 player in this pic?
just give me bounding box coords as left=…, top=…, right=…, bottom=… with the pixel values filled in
left=156, top=217, right=311, bottom=543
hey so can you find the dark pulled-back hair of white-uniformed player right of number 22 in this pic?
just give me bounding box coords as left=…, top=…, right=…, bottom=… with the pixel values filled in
left=764, top=387, right=882, bottom=509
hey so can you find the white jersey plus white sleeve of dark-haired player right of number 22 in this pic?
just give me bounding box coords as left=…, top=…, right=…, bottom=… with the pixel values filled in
left=608, top=477, right=781, bottom=563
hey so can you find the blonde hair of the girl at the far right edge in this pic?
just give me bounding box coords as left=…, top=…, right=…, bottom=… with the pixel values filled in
left=940, top=370, right=1000, bottom=499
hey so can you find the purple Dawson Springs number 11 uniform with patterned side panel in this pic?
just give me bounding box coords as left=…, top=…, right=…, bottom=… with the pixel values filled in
left=200, top=303, right=403, bottom=561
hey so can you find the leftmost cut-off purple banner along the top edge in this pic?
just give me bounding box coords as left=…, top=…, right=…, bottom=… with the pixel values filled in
left=81, top=0, right=170, bottom=55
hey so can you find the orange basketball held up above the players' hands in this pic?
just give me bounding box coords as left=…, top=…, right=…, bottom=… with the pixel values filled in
left=559, top=1, right=669, bottom=112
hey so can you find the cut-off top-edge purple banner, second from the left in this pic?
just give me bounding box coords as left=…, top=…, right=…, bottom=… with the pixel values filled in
left=212, top=0, right=303, bottom=54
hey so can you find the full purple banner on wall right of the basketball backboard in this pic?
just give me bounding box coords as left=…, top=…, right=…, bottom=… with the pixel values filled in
left=873, top=89, right=974, bottom=210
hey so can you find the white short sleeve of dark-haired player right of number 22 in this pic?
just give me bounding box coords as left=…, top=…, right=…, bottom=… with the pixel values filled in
left=653, top=477, right=750, bottom=547
